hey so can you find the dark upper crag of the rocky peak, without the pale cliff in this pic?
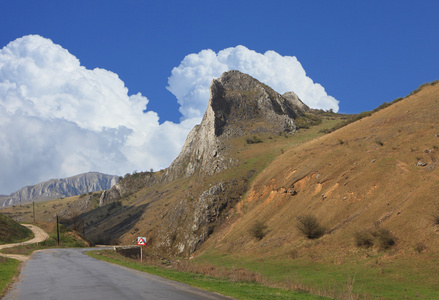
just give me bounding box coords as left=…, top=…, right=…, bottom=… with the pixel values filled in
left=209, top=71, right=303, bottom=136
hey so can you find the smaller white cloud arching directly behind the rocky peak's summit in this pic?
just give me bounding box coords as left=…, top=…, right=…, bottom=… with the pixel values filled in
left=167, top=46, right=338, bottom=119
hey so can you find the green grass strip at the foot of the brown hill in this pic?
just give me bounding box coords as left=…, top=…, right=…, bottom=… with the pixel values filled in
left=196, top=251, right=439, bottom=299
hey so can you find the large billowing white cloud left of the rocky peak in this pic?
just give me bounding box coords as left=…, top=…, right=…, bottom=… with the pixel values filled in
left=0, top=35, right=197, bottom=193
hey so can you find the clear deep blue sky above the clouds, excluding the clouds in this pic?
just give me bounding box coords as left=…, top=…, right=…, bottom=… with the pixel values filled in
left=0, top=0, right=439, bottom=121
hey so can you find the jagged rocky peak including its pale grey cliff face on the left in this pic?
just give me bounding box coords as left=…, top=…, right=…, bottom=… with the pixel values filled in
left=165, top=71, right=307, bottom=181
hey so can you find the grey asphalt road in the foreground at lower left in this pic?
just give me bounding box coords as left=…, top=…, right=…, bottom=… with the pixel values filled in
left=3, top=249, right=231, bottom=300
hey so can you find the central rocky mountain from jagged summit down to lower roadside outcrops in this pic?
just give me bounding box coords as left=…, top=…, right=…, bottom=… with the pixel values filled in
left=93, top=71, right=308, bottom=251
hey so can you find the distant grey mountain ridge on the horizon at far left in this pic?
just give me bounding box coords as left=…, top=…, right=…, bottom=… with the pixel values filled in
left=0, top=172, right=119, bottom=207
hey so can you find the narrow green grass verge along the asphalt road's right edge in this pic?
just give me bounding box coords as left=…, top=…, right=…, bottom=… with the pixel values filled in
left=87, top=251, right=327, bottom=299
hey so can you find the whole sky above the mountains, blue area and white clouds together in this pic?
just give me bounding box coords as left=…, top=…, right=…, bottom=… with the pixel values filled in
left=0, top=0, right=439, bottom=194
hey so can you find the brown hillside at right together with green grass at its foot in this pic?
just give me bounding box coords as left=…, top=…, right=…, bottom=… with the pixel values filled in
left=198, top=81, right=439, bottom=299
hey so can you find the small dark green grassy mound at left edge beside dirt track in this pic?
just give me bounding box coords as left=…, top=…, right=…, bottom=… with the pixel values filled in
left=0, top=214, right=33, bottom=244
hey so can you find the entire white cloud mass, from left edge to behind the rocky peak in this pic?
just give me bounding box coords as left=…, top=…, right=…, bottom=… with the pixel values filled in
left=0, top=35, right=338, bottom=194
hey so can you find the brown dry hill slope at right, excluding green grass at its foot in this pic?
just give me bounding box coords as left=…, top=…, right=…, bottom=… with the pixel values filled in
left=204, top=80, right=439, bottom=261
